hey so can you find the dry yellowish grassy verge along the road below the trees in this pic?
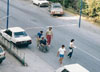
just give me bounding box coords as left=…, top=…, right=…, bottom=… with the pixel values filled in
left=65, top=8, right=100, bottom=27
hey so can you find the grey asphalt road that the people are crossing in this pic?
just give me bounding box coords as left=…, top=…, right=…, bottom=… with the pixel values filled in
left=0, top=0, right=100, bottom=72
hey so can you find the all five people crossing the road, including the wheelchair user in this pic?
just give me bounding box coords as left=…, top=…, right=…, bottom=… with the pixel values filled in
left=37, top=27, right=75, bottom=65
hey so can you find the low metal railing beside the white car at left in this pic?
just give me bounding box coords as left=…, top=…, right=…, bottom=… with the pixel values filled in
left=0, top=33, right=27, bottom=66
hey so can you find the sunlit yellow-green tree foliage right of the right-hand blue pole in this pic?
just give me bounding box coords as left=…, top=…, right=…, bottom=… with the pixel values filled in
left=83, top=0, right=100, bottom=17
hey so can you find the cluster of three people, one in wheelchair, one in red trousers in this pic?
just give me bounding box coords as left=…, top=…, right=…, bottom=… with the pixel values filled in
left=37, top=27, right=53, bottom=51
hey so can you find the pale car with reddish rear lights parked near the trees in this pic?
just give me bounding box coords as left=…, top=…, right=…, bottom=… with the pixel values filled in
left=49, top=3, right=64, bottom=15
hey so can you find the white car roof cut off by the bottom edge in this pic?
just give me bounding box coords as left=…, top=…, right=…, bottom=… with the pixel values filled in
left=56, top=63, right=89, bottom=72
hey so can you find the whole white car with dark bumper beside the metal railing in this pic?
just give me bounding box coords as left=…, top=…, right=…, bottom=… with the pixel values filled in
left=0, top=27, right=32, bottom=46
